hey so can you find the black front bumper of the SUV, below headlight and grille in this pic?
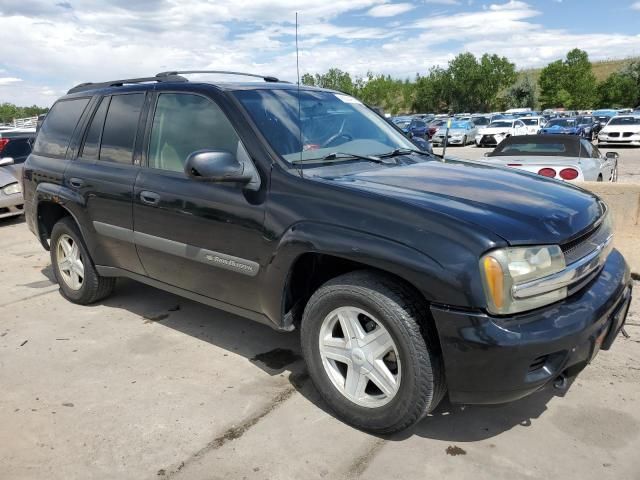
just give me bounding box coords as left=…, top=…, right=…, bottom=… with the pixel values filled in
left=431, top=250, right=631, bottom=404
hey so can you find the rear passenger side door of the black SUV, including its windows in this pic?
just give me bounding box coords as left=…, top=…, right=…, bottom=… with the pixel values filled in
left=65, top=92, right=146, bottom=274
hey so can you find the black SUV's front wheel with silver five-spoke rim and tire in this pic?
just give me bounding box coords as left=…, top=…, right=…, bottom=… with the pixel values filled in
left=301, top=271, right=445, bottom=434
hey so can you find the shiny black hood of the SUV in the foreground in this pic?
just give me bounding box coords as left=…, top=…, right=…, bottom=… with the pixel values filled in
left=330, top=161, right=602, bottom=245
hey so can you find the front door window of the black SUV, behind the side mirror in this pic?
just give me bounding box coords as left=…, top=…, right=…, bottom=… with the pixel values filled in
left=149, top=93, right=239, bottom=172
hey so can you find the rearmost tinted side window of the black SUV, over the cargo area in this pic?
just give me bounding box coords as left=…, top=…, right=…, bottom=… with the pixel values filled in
left=33, top=98, right=89, bottom=157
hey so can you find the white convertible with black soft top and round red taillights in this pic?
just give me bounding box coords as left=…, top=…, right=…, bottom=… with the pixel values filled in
left=485, top=135, right=619, bottom=182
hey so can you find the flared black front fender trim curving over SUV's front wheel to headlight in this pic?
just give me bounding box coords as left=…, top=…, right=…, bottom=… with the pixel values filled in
left=261, top=222, right=477, bottom=327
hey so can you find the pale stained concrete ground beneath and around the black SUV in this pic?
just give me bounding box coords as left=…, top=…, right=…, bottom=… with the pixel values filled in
left=0, top=197, right=640, bottom=480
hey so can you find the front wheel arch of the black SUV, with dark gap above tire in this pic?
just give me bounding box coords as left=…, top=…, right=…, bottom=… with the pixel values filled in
left=263, top=223, right=445, bottom=329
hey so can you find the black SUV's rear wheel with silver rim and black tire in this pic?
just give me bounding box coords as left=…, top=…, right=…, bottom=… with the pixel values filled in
left=51, top=217, right=116, bottom=305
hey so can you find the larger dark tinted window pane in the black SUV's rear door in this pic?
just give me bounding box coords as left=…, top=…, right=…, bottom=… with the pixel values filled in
left=100, top=93, right=144, bottom=164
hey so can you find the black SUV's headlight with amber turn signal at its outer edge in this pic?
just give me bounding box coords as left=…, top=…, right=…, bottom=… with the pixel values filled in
left=480, top=245, right=567, bottom=315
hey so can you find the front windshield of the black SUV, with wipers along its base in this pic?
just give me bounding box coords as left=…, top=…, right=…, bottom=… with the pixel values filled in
left=234, top=89, right=416, bottom=163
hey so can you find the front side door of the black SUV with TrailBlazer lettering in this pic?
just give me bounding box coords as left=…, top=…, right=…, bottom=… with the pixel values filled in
left=134, top=92, right=266, bottom=311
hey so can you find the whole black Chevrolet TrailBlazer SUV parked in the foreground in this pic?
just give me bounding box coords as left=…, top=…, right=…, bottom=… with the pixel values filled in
left=24, top=72, right=631, bottom=433
